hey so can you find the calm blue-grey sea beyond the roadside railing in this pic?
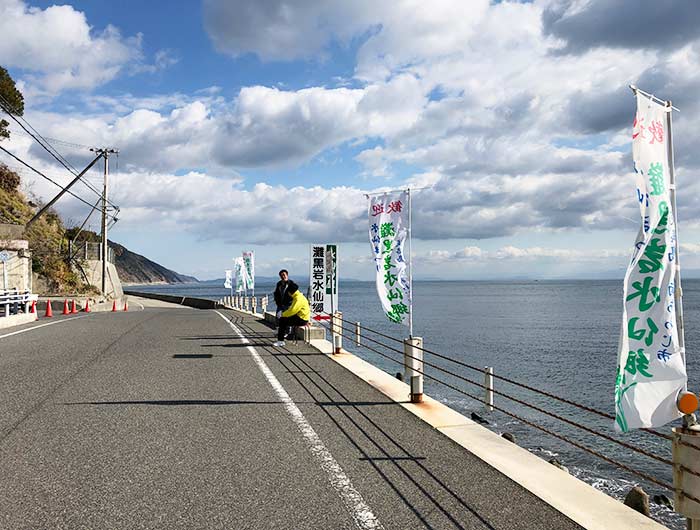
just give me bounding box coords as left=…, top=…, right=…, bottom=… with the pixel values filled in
left=130, top=278, right=700, bottom=530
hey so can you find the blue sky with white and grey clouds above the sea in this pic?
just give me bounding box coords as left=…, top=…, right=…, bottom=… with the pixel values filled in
left=0, top=0, right=700, bottom=280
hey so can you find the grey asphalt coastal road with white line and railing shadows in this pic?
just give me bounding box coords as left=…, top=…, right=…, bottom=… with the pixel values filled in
left=0, top=306, right=579, bottom=530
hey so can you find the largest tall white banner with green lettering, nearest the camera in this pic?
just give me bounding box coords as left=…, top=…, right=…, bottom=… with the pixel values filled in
left=615, top=93, right=687, bottom=432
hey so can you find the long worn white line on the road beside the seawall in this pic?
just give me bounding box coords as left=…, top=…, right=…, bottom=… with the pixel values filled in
left=216, top=311, right=384, bottom=530
